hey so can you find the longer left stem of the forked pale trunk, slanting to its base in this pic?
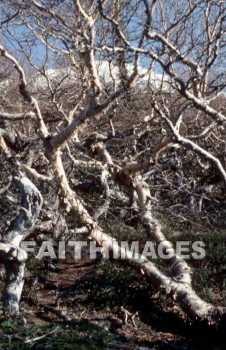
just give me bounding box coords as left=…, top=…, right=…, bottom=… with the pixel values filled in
left=49, top=143, right=225, bottom=323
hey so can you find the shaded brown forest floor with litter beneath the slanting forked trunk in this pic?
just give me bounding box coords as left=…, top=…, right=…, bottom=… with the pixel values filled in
left=0, top=228, right=226, bottom=350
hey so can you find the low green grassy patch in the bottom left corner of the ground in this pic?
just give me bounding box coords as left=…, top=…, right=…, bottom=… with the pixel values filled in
left=0, top=320, right=114, bottom=350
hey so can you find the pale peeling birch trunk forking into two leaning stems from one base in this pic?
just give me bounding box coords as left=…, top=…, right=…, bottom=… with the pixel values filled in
left=47, top=140, right=224, bottom=323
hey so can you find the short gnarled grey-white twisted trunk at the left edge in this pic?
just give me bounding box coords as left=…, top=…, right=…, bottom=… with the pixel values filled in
left=0, top=172, right=42, bottom=314
